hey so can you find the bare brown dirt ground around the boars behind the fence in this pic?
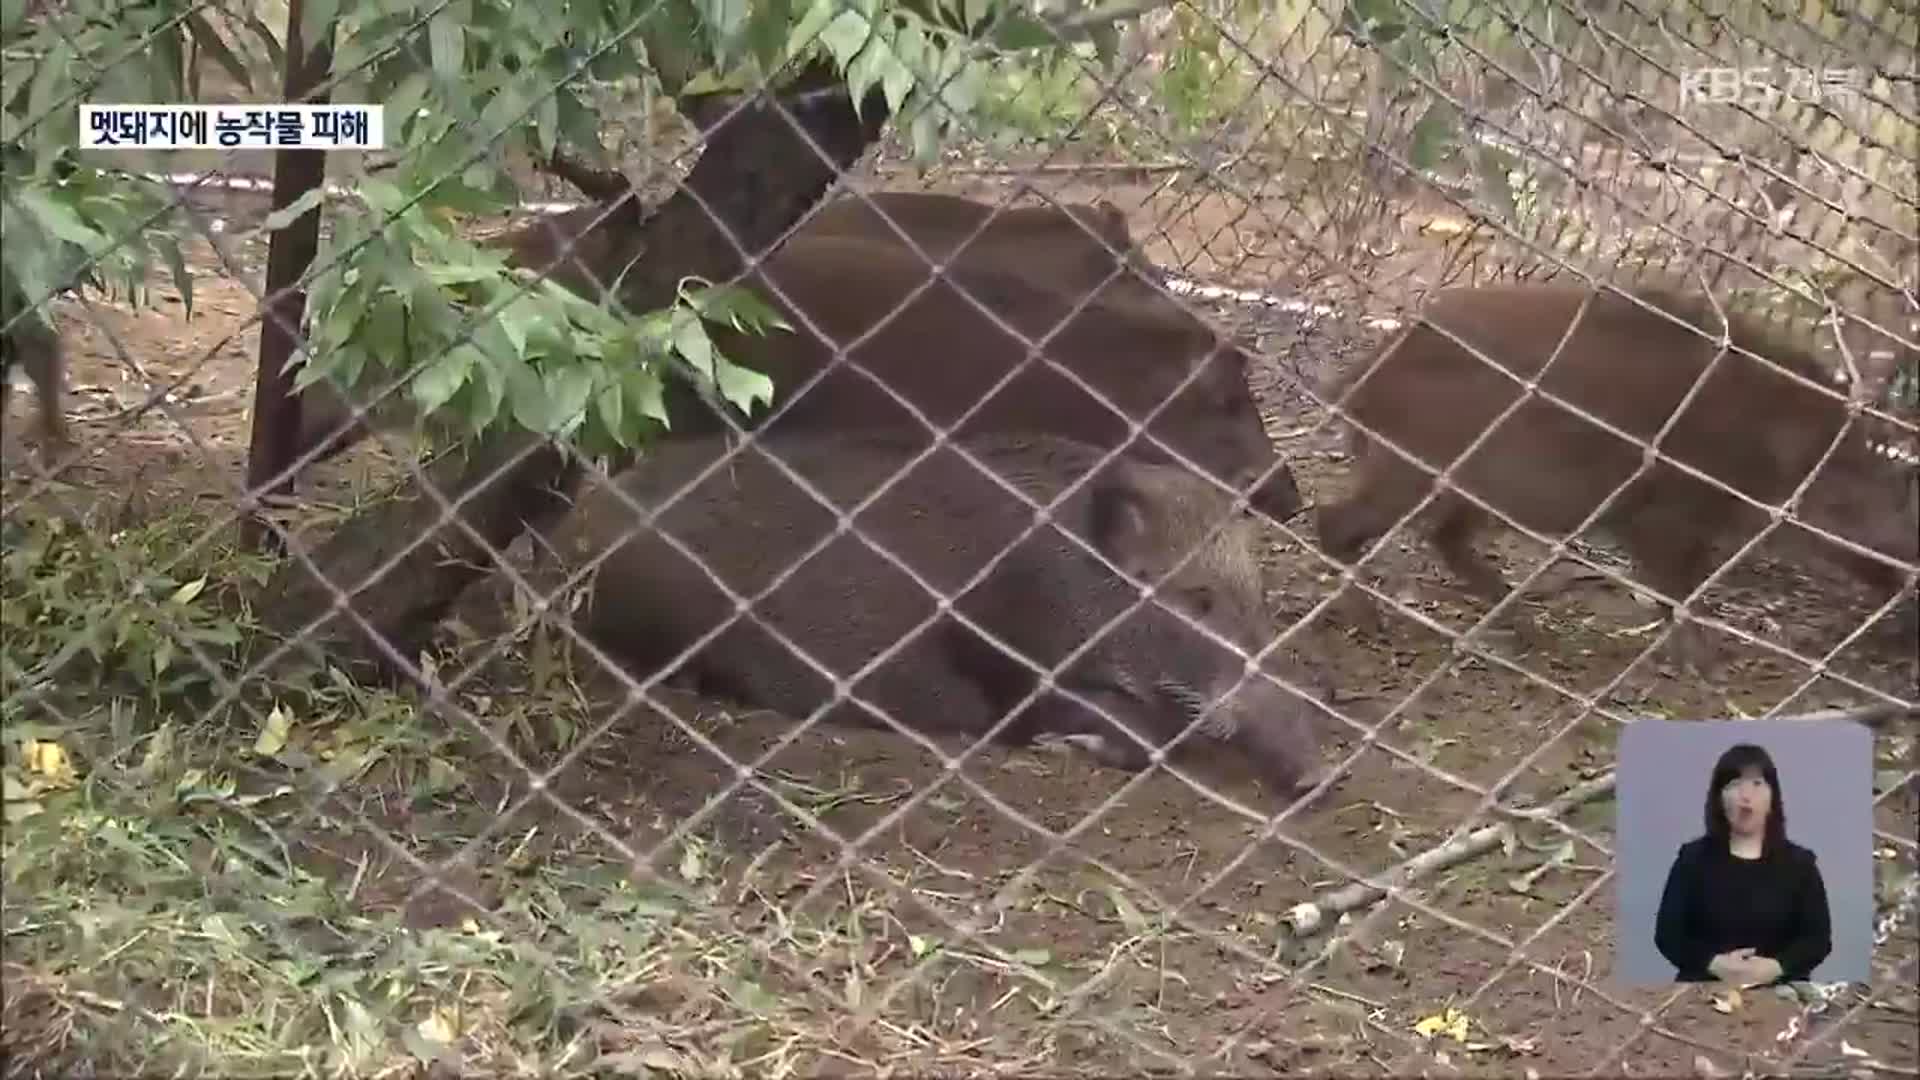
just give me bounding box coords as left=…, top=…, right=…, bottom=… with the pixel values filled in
left=8, top=155, right=1920, bottom=1076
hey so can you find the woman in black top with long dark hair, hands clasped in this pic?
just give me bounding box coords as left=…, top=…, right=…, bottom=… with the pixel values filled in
left=1653, top=744, right=1834, bottom=986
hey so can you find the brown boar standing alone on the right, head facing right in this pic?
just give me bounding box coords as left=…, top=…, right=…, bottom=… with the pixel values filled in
left=1315, top=284, right=1920, bottom=663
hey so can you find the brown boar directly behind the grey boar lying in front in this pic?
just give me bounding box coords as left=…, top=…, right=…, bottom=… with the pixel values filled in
left=301, top=211, right=1304, bottom=521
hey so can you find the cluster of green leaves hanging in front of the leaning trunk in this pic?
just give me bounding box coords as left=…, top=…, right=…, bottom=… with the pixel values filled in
left=296, top=179, right=789, bottom=454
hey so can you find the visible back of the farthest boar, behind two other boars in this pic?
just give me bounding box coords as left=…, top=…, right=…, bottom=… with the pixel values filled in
left=795, top=192, right=1167, bottom=319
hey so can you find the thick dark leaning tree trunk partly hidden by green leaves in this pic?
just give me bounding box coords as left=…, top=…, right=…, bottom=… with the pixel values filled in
left=255, top=65, right=887, bottom=675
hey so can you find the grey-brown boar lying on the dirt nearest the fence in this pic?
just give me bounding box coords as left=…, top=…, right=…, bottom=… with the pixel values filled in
left=536, top=432, right=1321, bottom=796
